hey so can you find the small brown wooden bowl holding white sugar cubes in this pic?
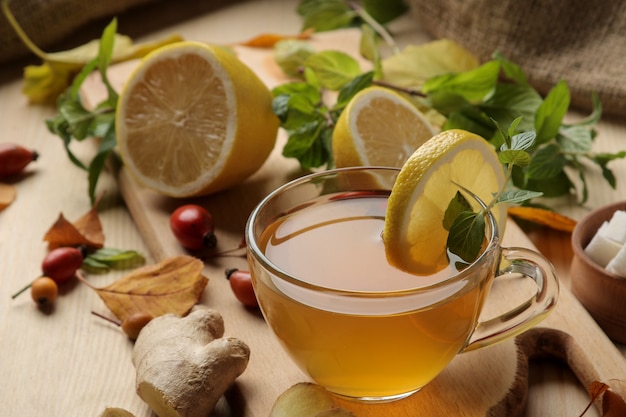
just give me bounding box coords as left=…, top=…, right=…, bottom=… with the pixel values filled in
left=570, top=201, right=626, bottom=343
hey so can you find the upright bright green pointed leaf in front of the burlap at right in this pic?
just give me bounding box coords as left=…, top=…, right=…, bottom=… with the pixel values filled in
left=535, top=80, right=570, bottom=144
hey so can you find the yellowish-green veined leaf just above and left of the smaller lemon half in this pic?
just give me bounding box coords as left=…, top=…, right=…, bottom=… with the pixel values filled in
left=304, top=50, right=361, bottom=91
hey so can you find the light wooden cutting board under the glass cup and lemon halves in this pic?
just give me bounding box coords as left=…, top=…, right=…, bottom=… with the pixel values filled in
left=83, top=30, right=626, bottom=417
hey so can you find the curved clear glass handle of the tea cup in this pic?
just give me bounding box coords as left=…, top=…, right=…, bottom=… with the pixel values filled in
left=462, top=248, right=559, bottom=352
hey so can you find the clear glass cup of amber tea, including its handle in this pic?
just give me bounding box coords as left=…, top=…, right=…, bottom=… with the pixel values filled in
left=245, top=167, right=559, bottom=401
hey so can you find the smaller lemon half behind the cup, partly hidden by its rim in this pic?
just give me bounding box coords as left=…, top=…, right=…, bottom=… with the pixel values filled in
left=332, top=86, right=436, bottom=168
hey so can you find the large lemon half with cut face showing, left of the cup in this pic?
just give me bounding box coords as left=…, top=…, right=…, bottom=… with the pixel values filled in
left=116, top=42, right=279, bottom=197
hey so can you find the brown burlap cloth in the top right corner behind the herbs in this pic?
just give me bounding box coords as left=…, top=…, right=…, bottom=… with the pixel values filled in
left=408, top=0, right=626, bottom=115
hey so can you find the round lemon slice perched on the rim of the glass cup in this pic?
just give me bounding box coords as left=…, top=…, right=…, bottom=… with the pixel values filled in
left=383, top=130, right=506, bottom=275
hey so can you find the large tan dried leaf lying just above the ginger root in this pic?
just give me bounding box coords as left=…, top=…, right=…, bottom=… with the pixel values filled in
left=92, top=255, right=208, bottom=321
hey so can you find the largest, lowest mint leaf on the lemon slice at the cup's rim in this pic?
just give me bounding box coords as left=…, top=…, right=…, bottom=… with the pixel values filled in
left=447, top=211, right=485, bottom=263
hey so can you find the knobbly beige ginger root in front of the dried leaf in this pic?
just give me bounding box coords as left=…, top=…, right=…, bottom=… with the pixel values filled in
left=132, top=306, right=250, bottom=417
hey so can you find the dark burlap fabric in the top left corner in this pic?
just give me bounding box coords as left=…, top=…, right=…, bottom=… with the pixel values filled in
left=0, top=0, right=154, bottom=64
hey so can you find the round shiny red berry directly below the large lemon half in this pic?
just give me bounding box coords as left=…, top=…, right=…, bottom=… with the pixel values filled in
left=170, top=204, right=217, bottom=249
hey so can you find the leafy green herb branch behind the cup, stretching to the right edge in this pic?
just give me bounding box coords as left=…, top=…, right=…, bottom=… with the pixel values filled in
left=273, top=0, right=626, bottom=205
